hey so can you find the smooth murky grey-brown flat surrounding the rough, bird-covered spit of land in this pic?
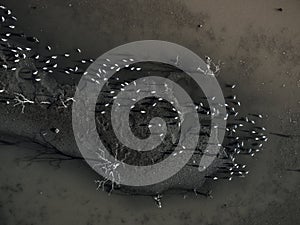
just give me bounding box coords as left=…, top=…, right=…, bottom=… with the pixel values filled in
left=0, top=0, right=300, bottom=225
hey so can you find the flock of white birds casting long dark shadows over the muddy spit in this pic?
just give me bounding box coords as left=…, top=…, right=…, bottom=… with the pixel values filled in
left=0, top=5, right=268, bottom=199
